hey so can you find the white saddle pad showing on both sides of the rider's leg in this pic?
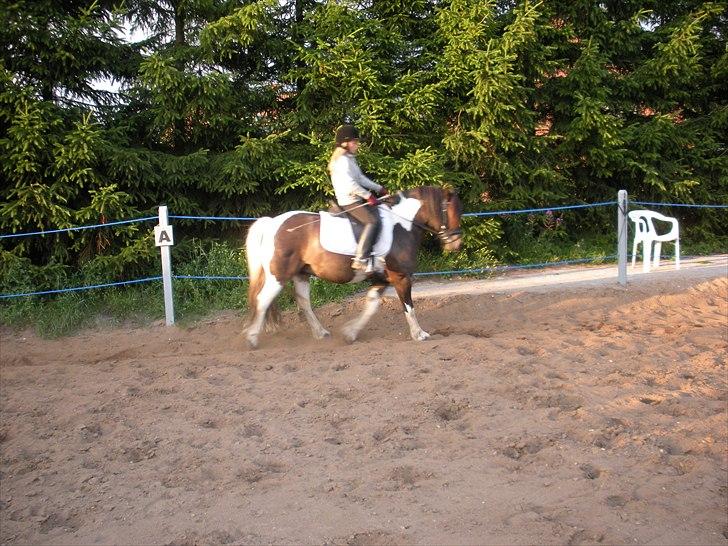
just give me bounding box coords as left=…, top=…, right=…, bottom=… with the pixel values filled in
left=319, top=203, right=393, bottom=256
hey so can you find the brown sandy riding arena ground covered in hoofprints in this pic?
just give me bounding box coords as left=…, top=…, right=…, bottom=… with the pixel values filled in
left=0, top=256, right=728, bottom=545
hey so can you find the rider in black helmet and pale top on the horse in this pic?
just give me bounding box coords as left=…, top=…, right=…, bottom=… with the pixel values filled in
left=329, top=125, right=387, bottom=272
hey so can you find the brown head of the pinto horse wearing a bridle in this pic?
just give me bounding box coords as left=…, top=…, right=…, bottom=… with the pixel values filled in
left=408, top=186, right=463, bottom=252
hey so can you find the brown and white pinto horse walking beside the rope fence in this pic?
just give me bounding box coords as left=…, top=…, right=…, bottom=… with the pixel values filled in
left=245, top=186, right=462, bottom=349
